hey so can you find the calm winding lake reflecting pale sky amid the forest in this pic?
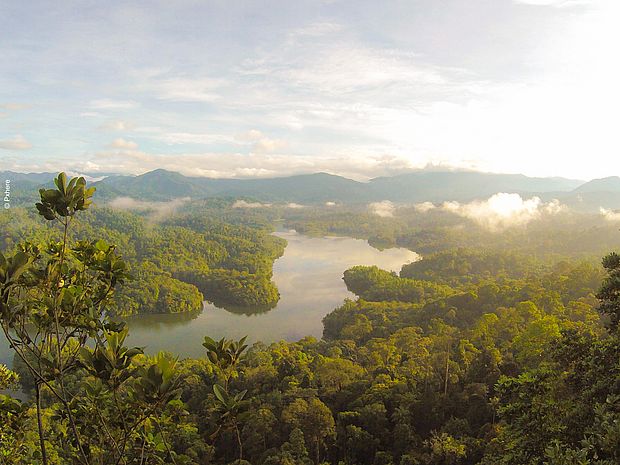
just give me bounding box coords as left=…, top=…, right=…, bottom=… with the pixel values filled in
left=0, top=231, right=419, bottom=365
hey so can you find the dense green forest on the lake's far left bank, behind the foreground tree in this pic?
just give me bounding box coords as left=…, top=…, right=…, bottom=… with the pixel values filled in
left=0, top=198, right=286, bottom=316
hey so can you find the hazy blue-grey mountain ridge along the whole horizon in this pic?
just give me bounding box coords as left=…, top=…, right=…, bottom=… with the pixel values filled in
left=7, top=169, right=620, bottom=209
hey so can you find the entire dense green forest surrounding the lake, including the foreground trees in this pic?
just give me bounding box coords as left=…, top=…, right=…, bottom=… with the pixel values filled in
left=0, top=174, right=620, bottom=465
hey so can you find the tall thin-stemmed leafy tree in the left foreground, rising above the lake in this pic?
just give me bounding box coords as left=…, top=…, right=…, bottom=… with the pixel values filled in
left=0, top=173, right=179, bottom=465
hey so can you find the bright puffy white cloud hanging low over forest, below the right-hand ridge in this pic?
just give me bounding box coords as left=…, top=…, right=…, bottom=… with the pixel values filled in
left=441, top=192, right=565, bottom=231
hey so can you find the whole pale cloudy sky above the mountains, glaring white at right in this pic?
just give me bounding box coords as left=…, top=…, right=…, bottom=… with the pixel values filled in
left=0, top=0, right=620, bottom=179
